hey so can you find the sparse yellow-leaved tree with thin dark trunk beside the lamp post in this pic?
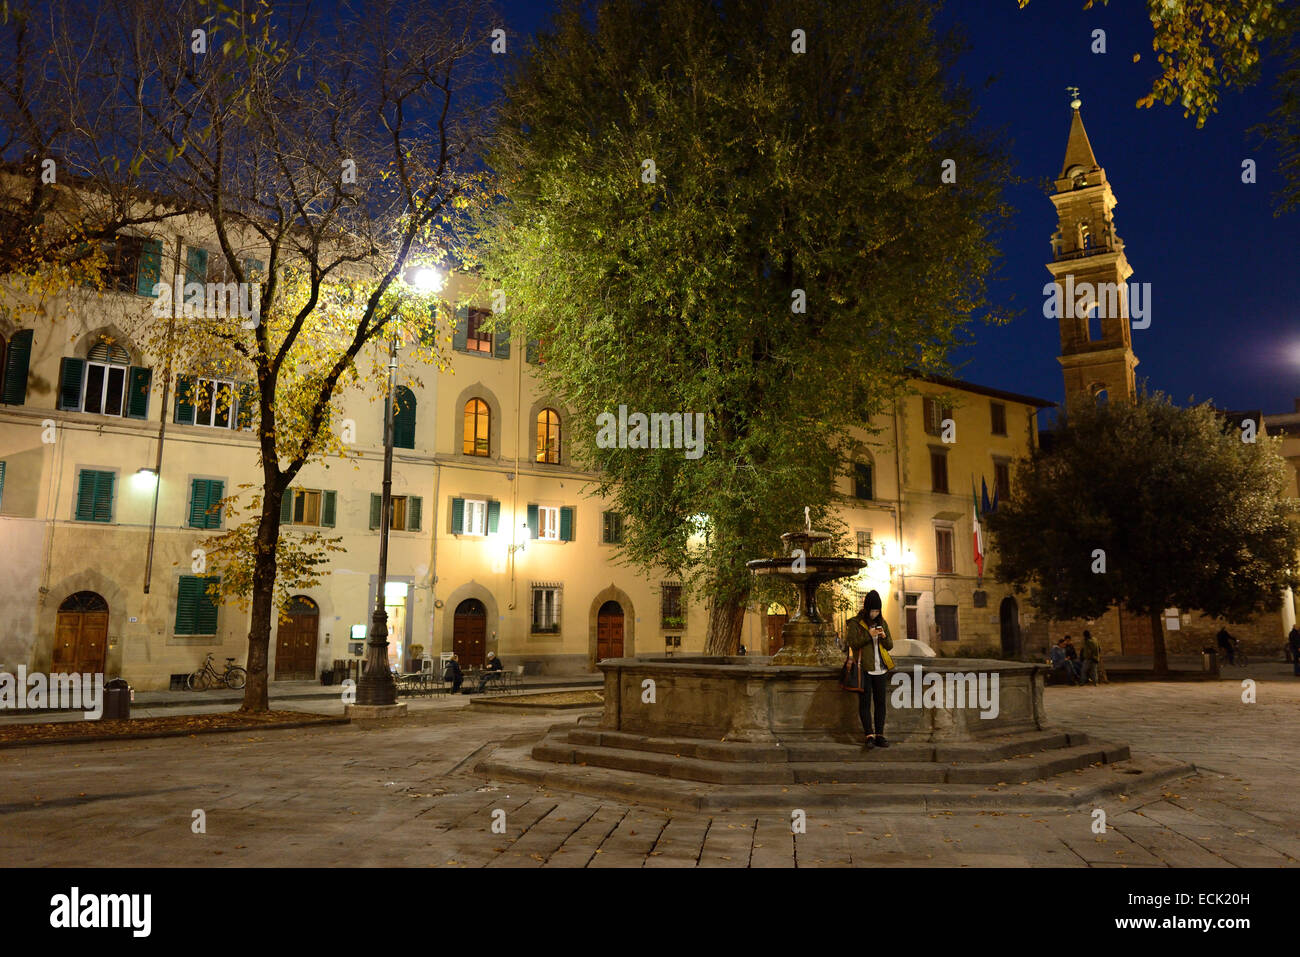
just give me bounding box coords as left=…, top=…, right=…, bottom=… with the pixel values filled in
left=7, top=0, right=490, bottom=711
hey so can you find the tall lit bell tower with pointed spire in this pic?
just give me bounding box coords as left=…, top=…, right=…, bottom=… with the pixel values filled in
left=1044, top=87, right=1149, bottom=413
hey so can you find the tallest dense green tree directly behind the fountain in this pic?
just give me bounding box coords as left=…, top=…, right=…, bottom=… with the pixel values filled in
left=476, top=0, right=1010, bottom=653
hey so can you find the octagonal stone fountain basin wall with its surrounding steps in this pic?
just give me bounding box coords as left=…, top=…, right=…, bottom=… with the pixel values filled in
left=477, top=655, right=1192, bottom=810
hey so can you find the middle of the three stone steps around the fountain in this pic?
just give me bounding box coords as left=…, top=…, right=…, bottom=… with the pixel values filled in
left=532, top=739, right=1128, bottom=785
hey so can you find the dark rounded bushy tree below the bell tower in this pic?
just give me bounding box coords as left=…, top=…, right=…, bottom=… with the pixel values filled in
left=987, top=394, right=1300, bottom=674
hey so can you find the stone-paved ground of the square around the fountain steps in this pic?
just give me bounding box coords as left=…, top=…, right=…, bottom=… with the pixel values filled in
left=0, top=676, right=1300, bottom=867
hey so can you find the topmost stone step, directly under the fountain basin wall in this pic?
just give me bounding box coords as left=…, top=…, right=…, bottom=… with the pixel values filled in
left=559, top=724, right=1088, bottom=763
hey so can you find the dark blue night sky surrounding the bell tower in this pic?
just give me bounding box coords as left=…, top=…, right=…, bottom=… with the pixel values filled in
left=503, top=0, right=1300, bottom=412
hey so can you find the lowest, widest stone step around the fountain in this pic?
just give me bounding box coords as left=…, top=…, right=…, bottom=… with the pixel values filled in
left=475, top=746, right=1195, bottom=814
